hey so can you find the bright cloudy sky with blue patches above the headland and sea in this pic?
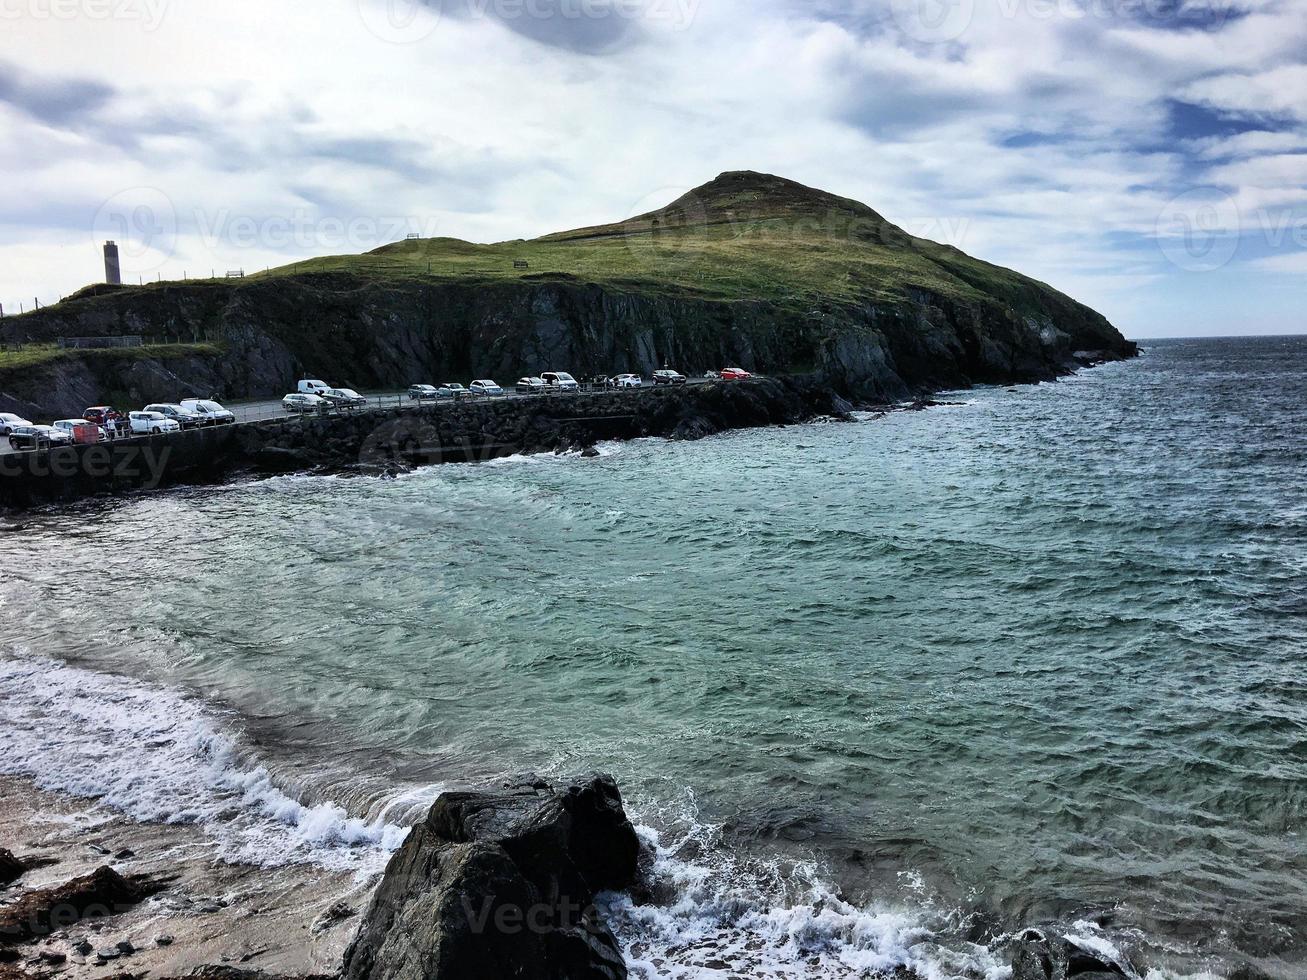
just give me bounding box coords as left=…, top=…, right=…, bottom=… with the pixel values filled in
left=0, top=0, right=1307, bottom=338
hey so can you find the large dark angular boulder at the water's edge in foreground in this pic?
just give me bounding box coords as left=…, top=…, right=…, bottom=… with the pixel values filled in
left=344, top=775, right=639, bottom=980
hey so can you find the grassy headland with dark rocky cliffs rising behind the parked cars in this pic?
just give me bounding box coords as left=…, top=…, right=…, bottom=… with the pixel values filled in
left=0, top=175, right=1134, bottom=416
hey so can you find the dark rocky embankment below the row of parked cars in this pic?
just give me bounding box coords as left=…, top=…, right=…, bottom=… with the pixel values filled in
left=0, top=354, right=1116, bottom=510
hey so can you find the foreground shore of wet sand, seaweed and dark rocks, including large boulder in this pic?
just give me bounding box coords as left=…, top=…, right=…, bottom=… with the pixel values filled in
left=0, top=774, right=1138, bottom=980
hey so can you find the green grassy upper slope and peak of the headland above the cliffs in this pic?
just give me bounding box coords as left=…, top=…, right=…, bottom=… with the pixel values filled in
left=260, top=172, right=1048, bottom=316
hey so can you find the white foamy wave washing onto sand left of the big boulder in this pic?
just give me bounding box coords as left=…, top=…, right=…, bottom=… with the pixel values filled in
left=0, top=657, right=413, bottom=872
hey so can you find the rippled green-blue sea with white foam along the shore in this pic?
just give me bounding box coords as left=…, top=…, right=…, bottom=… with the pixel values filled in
left=0, top=338, right=1307, bottom=976
